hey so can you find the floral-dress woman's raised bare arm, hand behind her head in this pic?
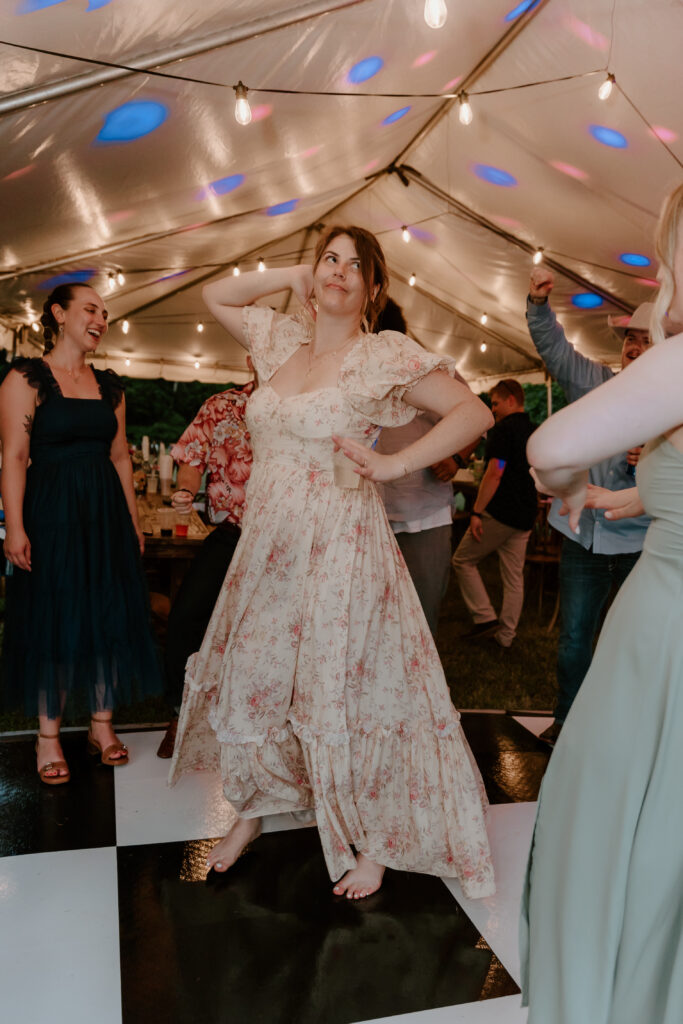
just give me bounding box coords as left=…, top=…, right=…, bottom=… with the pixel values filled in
left=202, top=263, right=315, bottom=348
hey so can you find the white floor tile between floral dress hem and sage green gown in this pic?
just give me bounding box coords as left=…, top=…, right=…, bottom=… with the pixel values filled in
left=439, top=804, right=537, bottom=987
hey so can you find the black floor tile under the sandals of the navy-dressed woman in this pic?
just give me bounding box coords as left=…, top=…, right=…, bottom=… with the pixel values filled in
left=0, top=732, right=116, bottom=857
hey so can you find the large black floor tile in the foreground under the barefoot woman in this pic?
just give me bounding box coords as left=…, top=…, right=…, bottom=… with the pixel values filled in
left=118, top=828, right=518, bottom=1024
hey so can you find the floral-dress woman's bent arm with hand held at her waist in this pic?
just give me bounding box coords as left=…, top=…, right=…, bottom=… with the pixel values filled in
left=333, top=370, right=494, bottom=482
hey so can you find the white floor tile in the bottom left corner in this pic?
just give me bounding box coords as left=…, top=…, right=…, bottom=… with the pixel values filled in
left=0, top=848, right=121, bottom=1024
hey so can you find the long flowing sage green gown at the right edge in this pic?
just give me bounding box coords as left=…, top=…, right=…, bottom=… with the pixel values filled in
left=520, top=438, right=683, bottom=1024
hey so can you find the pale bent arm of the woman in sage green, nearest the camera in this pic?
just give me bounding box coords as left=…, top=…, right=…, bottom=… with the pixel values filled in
left=526, top=335, right=683, bottom=527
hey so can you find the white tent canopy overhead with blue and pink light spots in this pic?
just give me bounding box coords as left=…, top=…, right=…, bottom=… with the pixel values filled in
left=0, top=0, right=683, bottom=388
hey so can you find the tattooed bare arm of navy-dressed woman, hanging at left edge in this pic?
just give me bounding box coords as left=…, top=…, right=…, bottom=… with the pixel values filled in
left=0, top=370, right=37, bottom=571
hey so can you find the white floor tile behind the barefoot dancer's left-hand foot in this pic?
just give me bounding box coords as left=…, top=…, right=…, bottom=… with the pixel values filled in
left=114, top=732, right=314, bottom=846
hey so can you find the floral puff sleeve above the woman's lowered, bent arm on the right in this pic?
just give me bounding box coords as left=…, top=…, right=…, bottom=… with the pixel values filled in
left=339, top=331, right=464, bottom=427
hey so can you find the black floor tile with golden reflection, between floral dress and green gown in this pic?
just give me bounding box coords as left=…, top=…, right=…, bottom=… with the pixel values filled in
left=461, top=712, right=552, bottom=804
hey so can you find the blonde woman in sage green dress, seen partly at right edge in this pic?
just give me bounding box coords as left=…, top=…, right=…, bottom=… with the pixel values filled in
left=521, top=185, right=683, bottom=1024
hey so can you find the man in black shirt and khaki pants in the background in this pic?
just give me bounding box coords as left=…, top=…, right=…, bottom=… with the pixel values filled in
left=453, top=379, right=537, bottom=647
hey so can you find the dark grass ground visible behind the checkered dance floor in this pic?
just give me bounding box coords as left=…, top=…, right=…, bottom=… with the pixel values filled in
left=0, top=555, right=558, bottom=732
